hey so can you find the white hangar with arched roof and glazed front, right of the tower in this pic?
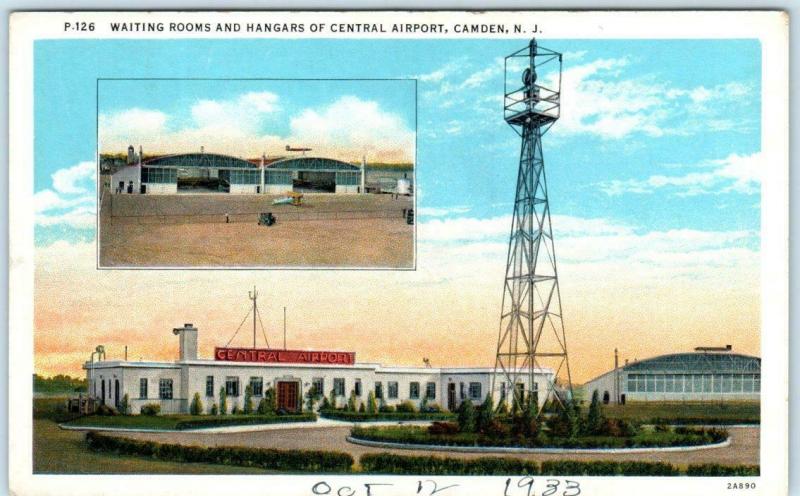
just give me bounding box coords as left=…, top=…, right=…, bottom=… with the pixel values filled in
left=584, top=345, right=761, bottom=404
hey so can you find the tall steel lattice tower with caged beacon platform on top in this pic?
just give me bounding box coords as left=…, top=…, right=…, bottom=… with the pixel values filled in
left=492, top=39, right=572, bottom=405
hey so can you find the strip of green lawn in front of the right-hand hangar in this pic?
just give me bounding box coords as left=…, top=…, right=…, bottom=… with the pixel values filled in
left=586, top=401, right=761, bottom=424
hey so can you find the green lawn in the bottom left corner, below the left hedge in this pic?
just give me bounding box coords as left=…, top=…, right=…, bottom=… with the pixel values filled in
left=33, top=419, right=276, bottom=474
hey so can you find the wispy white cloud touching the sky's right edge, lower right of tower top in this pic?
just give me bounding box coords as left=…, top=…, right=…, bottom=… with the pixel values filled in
left=599, top=153, right=764, bottom=196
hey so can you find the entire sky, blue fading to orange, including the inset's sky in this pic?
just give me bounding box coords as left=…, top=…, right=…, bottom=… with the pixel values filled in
left=34, top=40, right=764, bottom=382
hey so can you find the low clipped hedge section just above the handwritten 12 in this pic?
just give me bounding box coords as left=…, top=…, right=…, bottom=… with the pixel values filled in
left=359, top=453, right=539, bottom=475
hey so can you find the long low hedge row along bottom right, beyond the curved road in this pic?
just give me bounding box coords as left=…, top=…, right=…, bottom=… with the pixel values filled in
left=360, top=453, right=759, bottom=477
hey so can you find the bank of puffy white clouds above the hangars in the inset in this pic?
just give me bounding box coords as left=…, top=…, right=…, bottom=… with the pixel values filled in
left=100, top=92, right=414, bottom=161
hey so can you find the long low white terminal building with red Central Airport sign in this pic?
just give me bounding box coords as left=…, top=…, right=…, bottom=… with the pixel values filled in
left=83, top=324, right=553, bottom=414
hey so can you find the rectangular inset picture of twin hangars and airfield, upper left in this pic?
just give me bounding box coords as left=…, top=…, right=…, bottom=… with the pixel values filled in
left=97, top=79, right=416, bottom=269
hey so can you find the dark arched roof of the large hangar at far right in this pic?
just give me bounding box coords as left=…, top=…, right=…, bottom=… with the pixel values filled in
left=624, top=353, right=761, bottom=373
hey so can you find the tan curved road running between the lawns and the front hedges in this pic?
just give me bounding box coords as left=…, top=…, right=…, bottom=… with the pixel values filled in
left=103, top=426, right=759, bottom=466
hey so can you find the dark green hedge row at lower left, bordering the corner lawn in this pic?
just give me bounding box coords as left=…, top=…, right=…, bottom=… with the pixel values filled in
left=86, top=431, right=354, bottom=472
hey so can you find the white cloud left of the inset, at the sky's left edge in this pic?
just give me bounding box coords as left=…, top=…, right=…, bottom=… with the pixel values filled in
left=33, top=162, right=96, bottom=228
